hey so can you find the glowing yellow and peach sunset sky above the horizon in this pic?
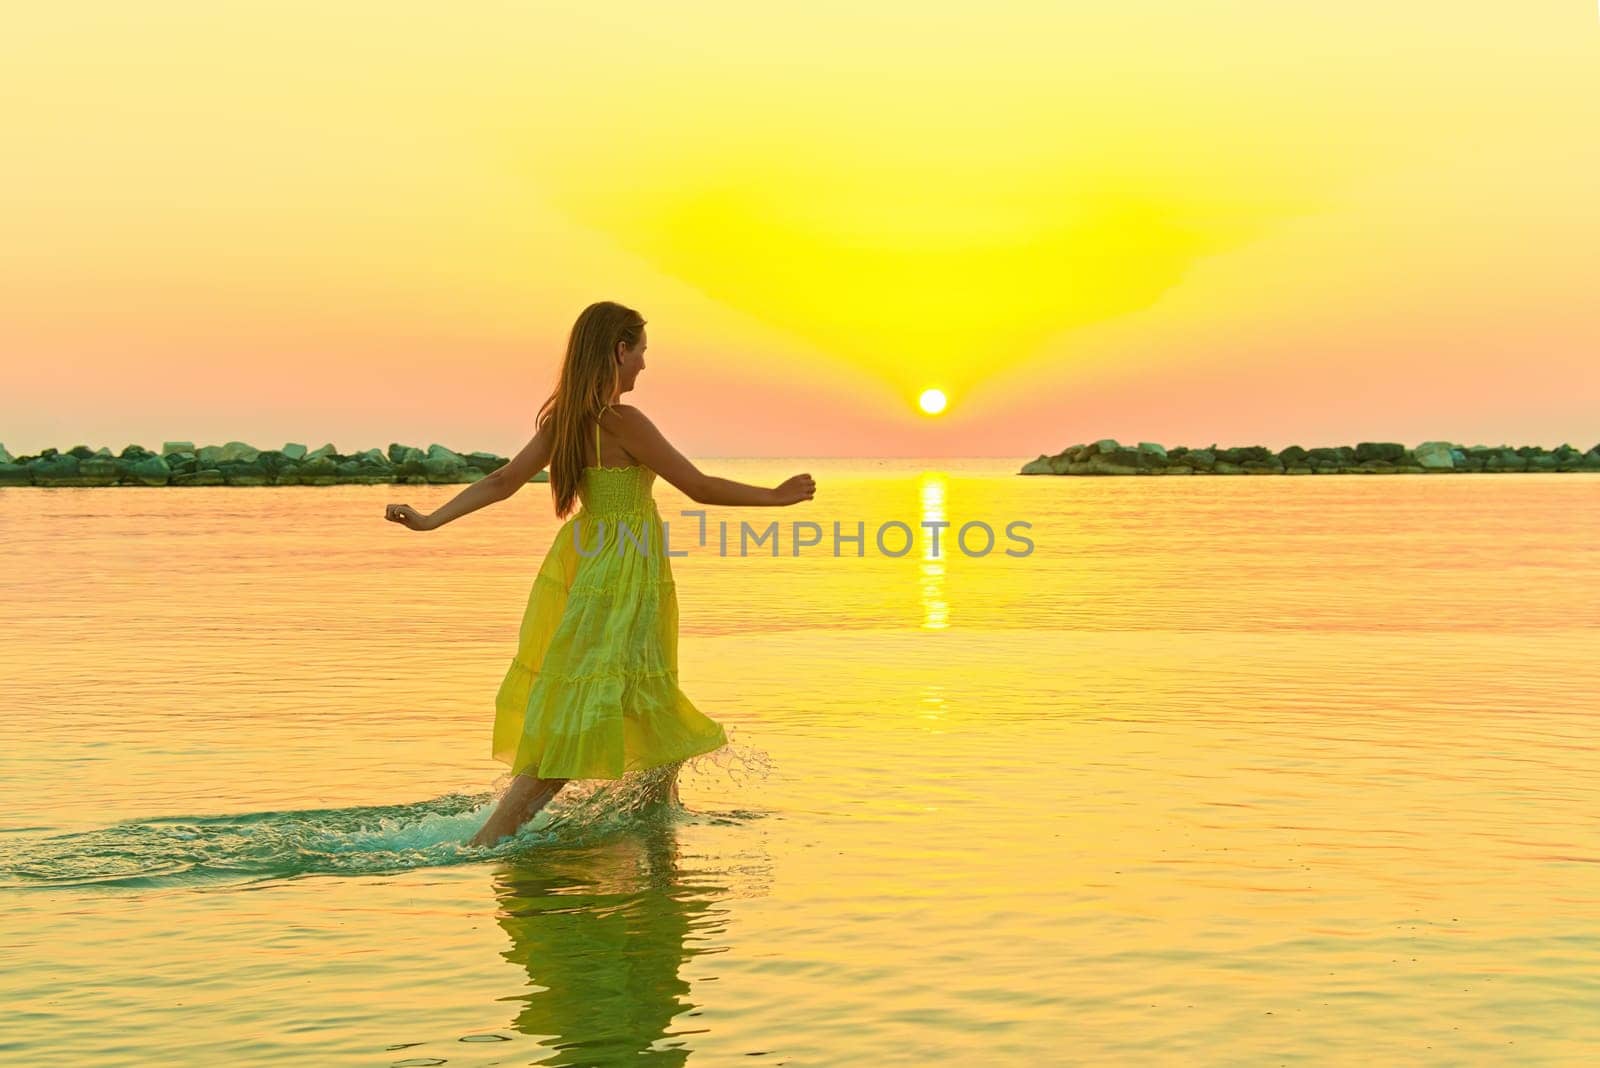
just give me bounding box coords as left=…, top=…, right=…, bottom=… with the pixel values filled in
left=0, top=0, right=1600, bottom=459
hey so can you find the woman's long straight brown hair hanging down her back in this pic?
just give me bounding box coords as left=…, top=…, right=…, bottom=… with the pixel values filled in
left=538, top=301, right=645, bottom=518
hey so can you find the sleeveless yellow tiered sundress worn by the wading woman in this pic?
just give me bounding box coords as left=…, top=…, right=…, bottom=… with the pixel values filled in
left=493, top=404, right=728, bottom=779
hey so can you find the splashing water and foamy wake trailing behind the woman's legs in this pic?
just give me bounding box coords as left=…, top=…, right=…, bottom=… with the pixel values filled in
left=0, top=755, right=763, bottom=889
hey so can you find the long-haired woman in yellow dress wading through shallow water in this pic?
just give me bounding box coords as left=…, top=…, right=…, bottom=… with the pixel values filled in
left=384, top=301, right=816, bottom=846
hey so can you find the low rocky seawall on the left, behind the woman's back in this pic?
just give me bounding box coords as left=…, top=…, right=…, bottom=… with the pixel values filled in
left=0, top=441, right=550, bottom=486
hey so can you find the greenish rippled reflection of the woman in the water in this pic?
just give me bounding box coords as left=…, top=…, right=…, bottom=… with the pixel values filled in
left=494, top=822, right=722, bottom=1065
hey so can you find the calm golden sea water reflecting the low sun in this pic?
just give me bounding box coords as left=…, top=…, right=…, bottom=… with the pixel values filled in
left=0, top=459, right=1600, bottom=1065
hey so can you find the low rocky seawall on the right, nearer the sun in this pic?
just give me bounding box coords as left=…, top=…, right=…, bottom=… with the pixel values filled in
left=1019, top=438, right=1600, bottom=475
